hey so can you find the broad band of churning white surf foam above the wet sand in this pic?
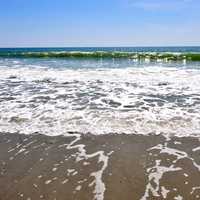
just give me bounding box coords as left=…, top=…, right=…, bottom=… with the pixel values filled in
left=0, top=63, right=200, bottom=136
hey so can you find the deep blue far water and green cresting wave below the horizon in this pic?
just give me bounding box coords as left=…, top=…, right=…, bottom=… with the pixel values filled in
left=0, top=47, right=200, bottom=62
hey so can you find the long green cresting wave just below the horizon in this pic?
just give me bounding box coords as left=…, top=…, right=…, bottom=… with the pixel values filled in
left=0, top=51, right=200, bottom=61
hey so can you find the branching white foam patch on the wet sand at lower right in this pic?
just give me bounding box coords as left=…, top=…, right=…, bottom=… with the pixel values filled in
left=141, top=143, right=200, bottom=200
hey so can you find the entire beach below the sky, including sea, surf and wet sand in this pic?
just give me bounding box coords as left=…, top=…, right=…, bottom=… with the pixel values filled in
left=0, top=47, right=200, bottom=200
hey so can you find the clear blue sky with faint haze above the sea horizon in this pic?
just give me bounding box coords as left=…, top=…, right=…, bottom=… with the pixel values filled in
left=0, top=0, right=200, bottom=47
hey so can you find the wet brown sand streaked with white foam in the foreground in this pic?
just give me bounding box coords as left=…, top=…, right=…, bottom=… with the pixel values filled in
left=0, top=133, right=200, bottom=200
